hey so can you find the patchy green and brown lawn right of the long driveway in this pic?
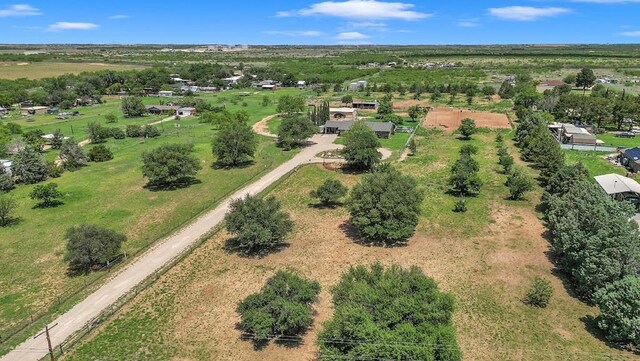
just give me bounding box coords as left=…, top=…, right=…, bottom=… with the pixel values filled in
left=63, top=132, right=631, bottom=361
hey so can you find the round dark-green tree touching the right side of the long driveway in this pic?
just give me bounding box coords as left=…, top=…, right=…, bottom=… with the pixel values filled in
left=225, top=195, right=293, bottom=256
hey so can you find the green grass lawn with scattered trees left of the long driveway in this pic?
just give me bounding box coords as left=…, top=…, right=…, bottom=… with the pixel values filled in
left=0, top=89, right=306, bottom=348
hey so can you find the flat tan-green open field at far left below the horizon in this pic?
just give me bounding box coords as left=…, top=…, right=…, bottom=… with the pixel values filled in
left=0, top=62, right=143, bottom=79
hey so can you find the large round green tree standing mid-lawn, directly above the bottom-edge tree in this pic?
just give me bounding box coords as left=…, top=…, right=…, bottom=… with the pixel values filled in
left=349, top=166, right=423, bottom=244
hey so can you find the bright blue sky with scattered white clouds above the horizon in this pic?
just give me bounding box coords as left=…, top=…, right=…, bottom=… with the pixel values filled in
left=0, top=0, right=640, bottom=45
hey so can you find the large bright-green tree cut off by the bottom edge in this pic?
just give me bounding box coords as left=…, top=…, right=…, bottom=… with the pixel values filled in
left=317, top=264, right=462, bottom=361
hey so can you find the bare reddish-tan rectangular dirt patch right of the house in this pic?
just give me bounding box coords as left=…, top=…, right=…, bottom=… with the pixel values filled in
left=423, top=107, right=511, bottom=131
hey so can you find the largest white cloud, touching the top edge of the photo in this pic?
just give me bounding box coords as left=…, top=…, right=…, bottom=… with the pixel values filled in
left=276, top=0, right=432, bottom=20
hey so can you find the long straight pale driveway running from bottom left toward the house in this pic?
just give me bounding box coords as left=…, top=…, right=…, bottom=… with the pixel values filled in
left=0, top=135, right=336, bottom=361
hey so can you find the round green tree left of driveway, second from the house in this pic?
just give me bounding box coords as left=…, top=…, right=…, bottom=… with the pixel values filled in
left=211, top=119, right=258, bottom=166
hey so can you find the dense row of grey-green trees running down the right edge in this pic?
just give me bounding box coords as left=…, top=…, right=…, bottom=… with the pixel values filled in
left=515, top=106, right=640, bottom=345
